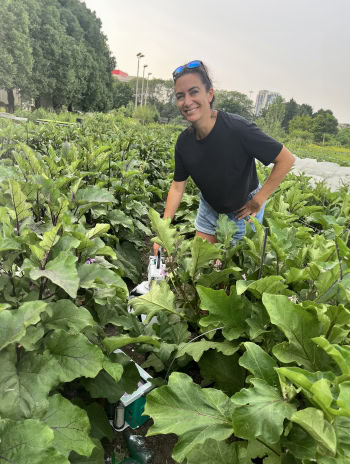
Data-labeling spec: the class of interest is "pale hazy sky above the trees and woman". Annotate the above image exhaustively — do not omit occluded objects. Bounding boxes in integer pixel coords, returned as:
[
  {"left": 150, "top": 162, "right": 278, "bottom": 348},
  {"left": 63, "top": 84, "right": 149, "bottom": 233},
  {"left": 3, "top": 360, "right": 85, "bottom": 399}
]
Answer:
[{"left": 85, "top": 0, "right": 350, "bottom": 123}]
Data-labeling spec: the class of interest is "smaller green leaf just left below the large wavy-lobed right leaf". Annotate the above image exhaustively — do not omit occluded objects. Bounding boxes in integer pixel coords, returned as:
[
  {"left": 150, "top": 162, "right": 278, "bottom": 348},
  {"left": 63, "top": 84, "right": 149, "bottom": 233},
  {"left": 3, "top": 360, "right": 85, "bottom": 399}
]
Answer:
[{"left": 239, "top": 342, "right": 279, "bottom": 387}]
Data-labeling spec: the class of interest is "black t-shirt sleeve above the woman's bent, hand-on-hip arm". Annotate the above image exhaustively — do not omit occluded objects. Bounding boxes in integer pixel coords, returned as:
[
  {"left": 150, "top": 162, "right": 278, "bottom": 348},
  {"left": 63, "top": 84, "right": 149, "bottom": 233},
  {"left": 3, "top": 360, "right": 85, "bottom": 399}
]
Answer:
[{"left": 241, "top": 122, "right": 283, "bottom": 166}]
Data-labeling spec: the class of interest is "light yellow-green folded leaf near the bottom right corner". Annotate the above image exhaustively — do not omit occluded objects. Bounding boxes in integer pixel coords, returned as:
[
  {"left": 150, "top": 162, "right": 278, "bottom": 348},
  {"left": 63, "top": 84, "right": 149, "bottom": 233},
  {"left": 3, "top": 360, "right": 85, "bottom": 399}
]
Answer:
[{"left": 291, "top": 408, "right": 337, "bottom": 455}]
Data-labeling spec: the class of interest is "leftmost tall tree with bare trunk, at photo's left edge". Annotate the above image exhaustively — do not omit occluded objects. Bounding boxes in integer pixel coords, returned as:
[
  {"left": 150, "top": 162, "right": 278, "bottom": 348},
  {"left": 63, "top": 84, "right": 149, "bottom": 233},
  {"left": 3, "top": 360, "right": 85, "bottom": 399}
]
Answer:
[{"left": 0, "top": 0, "right": 33, "bottom": 112}]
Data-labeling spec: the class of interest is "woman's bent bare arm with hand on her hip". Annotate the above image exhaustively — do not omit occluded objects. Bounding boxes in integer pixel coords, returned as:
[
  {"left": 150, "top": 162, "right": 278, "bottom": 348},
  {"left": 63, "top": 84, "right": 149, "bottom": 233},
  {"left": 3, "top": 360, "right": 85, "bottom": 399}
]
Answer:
[{"left": 237, "top": 147, "right": 295, "bottom": 219}]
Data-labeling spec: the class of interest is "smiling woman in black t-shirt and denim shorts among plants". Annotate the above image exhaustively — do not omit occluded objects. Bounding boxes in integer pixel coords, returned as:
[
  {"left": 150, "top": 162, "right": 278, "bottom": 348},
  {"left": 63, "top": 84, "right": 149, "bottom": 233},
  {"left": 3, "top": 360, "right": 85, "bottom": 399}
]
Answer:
[{"left": 153, "top": 60, "right": 295, "bottom": 255}]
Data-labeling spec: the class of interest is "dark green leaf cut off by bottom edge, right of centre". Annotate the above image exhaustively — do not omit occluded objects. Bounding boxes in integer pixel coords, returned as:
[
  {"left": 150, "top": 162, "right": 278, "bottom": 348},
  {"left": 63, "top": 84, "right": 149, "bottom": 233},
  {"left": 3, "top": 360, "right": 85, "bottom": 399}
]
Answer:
[{"left": 187, "top": 438, "right": 242, "bottom": 464}]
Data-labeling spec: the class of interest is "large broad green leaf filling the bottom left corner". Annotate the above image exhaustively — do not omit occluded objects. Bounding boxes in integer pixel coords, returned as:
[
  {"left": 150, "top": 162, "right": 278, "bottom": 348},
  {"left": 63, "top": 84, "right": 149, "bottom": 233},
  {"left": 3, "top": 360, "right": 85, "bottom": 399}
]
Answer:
[{"left": 0, "top": 419, "right": 69, "bottom": 464}]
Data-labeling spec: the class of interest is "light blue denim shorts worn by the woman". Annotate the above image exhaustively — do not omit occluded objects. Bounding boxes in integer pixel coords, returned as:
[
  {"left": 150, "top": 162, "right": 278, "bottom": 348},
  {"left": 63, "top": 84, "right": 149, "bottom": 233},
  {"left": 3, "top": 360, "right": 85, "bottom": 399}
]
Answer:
[{"left": 194, "top": 184, "right": 265, "bottom": 245}]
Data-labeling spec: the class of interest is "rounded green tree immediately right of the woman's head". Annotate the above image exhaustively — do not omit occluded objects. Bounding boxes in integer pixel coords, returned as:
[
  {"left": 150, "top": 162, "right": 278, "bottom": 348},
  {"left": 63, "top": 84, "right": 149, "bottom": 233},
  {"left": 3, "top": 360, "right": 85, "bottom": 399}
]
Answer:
[{"left": 214, "top": 90, "right": 253, "bottom": 119}]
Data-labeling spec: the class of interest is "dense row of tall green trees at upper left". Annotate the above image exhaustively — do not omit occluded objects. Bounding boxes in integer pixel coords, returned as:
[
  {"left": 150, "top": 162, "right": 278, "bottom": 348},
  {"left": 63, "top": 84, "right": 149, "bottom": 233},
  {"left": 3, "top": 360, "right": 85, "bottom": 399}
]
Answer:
[{"left": 0, "top": 0, "right": 116, "bottom": 111}]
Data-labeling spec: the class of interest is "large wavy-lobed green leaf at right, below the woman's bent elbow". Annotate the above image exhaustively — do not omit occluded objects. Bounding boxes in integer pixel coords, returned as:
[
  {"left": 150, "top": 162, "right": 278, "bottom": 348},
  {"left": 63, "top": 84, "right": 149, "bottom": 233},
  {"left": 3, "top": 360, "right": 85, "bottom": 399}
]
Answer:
[{"left": 263, "top": 294, "right": 327, "bottom": 371}]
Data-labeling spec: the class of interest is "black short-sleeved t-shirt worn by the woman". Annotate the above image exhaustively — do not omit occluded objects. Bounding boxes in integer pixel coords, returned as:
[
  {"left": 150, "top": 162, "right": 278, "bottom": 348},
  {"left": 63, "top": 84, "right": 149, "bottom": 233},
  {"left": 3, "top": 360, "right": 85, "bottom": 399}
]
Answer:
[{"left": 174, "top": 111, "right": 283, "bottom": 213}]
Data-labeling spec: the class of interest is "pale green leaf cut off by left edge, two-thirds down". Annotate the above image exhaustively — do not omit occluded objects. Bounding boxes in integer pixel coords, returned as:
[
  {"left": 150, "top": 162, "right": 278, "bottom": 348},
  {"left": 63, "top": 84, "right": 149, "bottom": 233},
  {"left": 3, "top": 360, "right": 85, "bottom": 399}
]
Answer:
[{"left": 0, "top": 301, "right": 47, "bottom": 350}]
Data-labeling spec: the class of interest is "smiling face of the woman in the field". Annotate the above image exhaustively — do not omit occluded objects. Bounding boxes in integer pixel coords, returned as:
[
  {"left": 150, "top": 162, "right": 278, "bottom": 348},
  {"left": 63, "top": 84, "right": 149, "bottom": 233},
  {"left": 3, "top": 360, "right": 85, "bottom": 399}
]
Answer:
[{"left": 175, "top": 73, "right": 214, "bottom": 123}]
